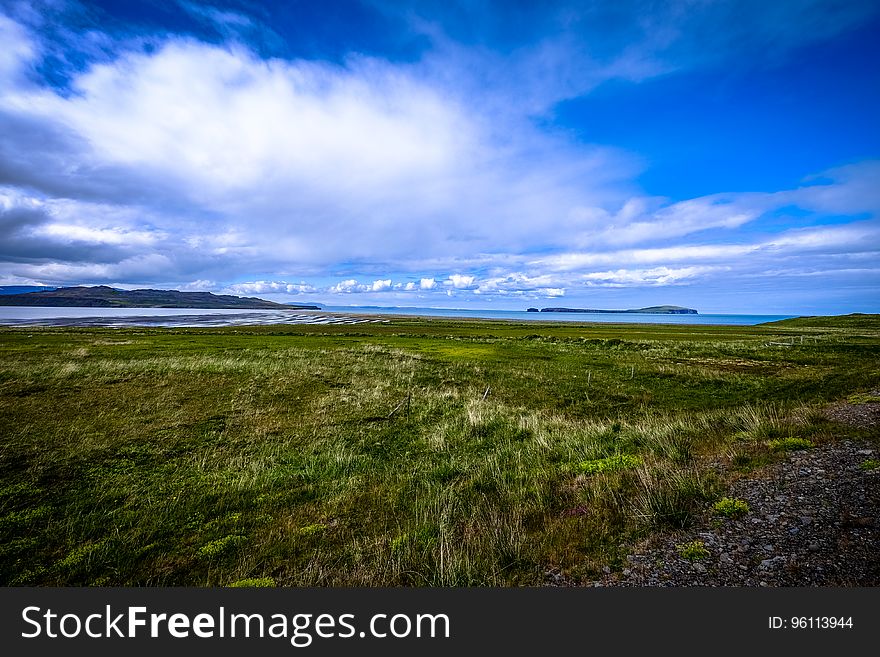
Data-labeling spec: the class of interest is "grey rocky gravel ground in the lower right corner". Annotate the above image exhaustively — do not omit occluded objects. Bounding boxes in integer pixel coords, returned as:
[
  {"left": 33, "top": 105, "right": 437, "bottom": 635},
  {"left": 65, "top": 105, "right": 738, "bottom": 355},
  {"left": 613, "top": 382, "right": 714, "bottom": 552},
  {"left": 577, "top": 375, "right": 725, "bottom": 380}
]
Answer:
[{"left": 580, "top": 393, "right": 880, "bottom": 586}]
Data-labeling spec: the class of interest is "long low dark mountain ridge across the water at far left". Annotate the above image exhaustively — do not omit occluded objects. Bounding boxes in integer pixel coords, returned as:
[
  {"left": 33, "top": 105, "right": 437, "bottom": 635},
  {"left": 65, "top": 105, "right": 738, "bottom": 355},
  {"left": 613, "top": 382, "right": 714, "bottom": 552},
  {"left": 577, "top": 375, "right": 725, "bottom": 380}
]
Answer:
[{"left": 0, "top": 285, "right": 320, "bottom": 310}]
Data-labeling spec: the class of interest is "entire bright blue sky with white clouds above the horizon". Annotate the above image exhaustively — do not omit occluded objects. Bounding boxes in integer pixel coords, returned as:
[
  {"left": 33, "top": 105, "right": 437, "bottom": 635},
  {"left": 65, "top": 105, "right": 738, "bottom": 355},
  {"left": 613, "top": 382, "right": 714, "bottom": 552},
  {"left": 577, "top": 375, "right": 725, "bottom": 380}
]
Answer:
[{"left": 0, "top": 0, "right": 880, "bottom": 314}]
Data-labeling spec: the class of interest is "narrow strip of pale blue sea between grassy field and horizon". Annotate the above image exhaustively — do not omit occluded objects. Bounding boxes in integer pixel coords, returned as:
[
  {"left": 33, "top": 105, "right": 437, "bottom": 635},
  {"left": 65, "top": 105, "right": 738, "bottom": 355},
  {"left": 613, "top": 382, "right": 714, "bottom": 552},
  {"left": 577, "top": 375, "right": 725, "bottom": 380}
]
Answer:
[{"left": 0, "top": 306, "right": 796, "bottom": 327}]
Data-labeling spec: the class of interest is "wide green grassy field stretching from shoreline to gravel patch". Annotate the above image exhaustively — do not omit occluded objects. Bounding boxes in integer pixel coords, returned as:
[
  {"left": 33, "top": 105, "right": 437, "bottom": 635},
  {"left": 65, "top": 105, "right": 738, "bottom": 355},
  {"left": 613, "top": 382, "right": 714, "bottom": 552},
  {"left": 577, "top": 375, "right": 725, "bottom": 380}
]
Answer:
[{"left": 0, "top": 315, "right": 880, "bottom": 586}]
